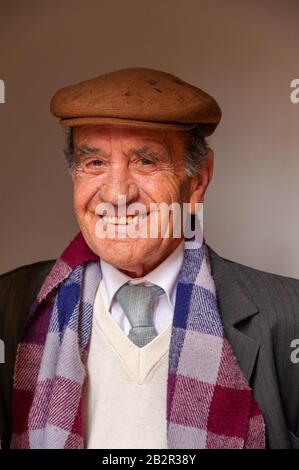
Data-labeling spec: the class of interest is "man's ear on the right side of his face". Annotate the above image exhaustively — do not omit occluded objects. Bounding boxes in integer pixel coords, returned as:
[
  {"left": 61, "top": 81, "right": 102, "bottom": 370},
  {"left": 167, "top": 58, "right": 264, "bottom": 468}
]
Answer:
[{"left": 190, "top": 149, "right": 214, "bottom": 214}]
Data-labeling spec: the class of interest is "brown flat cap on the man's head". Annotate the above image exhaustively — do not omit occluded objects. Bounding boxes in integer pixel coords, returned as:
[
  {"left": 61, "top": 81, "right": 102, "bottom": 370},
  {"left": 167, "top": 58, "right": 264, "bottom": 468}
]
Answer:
[{"left": 51, "top": 68, "right": 221, "bottom": 135}]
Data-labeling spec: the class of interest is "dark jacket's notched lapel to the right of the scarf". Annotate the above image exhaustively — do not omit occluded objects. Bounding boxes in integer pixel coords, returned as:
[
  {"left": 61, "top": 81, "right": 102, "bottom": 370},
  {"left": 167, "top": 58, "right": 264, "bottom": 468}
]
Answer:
[{"left": 208, "top": 246, "right": 260, "bottom": 383}]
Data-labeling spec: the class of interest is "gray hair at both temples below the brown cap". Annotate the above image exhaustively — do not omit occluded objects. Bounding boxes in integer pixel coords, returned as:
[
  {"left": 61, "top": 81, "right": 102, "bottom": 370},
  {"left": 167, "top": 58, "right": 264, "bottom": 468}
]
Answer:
[{"left": 64, "top": 126, "right": 209, "bottom": 177}]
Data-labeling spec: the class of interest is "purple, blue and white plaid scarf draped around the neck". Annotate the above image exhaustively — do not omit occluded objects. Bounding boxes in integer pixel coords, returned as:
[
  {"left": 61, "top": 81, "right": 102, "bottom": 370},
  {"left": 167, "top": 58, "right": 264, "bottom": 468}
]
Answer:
[{"left": 11, "top": 233, "right": 265, "bottom": 449}]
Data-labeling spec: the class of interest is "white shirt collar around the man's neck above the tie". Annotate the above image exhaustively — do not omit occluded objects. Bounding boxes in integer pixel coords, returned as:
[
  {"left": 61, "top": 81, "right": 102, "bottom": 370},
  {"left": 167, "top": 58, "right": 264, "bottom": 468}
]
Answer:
[{"left": 100, "top": 240, "right": 184, "bottom": 310}]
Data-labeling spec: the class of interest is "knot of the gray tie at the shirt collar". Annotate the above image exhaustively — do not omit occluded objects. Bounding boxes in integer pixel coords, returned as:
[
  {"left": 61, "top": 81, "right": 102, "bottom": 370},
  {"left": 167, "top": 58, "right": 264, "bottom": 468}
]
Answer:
[{"left": 115, "top": 284, "right": 165, "bottom": 328}]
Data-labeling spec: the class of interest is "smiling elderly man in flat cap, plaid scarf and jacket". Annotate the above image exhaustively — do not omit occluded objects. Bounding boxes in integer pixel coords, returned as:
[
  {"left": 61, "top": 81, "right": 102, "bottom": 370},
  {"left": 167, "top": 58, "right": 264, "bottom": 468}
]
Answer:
[{"left": 0, "top": 69, "right": 299, "bottom": 449}]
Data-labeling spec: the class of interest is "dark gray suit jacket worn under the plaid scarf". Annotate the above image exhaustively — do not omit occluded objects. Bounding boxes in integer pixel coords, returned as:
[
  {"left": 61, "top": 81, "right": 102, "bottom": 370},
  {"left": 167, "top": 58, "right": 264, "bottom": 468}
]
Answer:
[{"left": 0, "top": 247, "right": 299, "bottom": 449}]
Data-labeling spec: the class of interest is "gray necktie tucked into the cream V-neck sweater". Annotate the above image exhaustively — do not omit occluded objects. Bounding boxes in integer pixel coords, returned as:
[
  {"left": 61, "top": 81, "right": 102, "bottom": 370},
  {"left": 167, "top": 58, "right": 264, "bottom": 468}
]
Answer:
[{"left": 115, "top": 284, "right": 165, "bottom": 348}]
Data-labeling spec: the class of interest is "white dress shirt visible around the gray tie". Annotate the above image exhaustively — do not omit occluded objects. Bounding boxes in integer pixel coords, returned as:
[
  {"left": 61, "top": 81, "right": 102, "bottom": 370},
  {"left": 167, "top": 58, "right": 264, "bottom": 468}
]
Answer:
[{"left": 101, "top": 240, "right": 184, "bottom": 335}]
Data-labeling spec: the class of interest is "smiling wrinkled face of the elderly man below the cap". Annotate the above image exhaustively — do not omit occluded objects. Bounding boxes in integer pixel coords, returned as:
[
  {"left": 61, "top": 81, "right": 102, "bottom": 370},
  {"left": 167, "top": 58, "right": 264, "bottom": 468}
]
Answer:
[{"left": 73, "top": 126, "right": 212, "bottom": 277}]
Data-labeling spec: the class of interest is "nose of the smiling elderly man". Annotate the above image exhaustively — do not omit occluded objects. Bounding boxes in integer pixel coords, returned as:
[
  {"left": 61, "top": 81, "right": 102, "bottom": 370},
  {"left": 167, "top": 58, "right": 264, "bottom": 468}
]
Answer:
[{"left": 99, "top": 167, "right": 139, "bottom": 206}]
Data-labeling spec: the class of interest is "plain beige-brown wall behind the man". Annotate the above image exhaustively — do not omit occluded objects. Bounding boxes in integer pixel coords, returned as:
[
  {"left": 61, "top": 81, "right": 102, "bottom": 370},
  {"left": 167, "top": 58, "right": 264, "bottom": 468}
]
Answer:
[{"left": 0, "top": 0, "right": 299, "bottom": 278}]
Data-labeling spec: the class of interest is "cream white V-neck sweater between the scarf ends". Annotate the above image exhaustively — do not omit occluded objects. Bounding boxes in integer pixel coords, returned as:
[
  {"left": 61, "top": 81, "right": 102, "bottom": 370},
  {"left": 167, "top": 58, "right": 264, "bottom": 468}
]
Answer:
[{"left": 84, "top": 283, "right": 171, "bottom": 449}]
